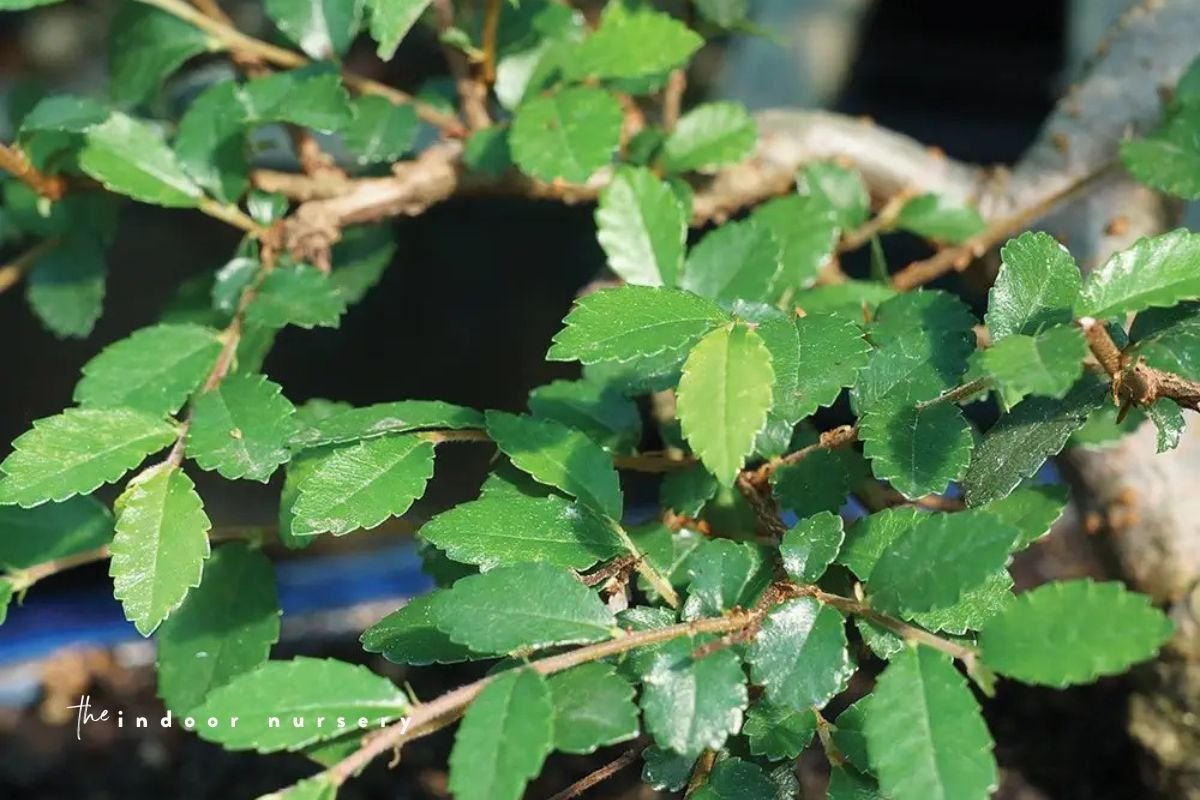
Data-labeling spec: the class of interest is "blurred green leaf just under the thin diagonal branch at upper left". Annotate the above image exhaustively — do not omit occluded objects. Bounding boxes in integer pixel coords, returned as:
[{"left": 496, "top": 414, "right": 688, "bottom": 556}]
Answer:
[{"left": 241, "top": 64, "right": 354, "bottom": 133}]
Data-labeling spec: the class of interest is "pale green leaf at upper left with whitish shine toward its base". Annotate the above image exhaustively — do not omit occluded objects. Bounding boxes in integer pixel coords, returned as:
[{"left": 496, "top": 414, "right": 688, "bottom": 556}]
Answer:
[{"left": 79, "top": 114, "right": 204, "bottom": 207}]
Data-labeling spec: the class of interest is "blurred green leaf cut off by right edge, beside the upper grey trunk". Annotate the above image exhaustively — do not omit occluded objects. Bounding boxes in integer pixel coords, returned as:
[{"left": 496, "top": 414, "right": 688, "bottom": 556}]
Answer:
[{"left": 1121, "top": 103, "right": 1200, "bottom": 200}]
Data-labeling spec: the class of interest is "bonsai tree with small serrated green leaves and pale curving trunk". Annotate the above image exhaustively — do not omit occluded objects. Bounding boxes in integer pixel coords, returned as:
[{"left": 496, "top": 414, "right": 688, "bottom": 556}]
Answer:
[{"left": 0, "top": 0, "right": 1200, "bottom": 800}]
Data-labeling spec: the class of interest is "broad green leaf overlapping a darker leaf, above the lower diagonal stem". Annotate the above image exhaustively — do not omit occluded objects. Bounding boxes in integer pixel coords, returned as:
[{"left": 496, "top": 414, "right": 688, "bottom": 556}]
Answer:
[{"left": 430, "top": 564, "right": 616, "bottom": 654}]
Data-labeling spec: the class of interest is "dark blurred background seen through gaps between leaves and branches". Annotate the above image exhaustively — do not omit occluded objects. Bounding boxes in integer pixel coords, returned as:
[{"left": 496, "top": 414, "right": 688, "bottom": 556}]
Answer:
[{"left": 0, "top": 0, "right": 1142, "bottom": 800}]
